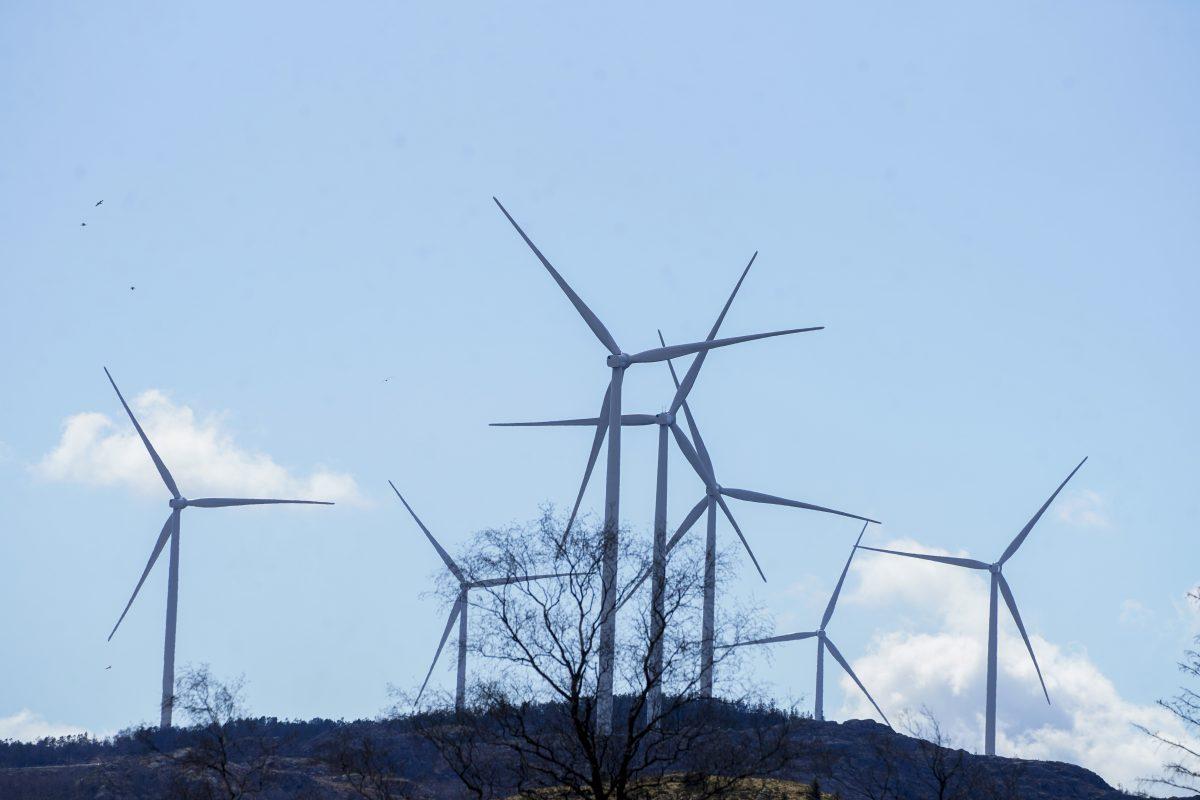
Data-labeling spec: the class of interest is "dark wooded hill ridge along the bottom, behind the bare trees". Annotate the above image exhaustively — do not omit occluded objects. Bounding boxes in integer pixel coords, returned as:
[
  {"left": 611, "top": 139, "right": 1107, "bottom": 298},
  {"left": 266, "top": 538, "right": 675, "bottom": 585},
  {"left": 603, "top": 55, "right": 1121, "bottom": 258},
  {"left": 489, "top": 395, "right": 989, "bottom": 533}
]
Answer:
[{"left": 0, "top": 718, "right": 1180, "bottom": 800}]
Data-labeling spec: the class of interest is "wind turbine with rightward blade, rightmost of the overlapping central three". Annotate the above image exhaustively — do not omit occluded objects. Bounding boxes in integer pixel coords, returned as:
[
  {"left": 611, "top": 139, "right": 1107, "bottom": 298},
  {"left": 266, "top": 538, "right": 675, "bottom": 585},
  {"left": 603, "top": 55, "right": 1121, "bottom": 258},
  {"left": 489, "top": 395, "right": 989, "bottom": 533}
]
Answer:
[{"left": 659, "top": 340, "right": 877, "bottom": 697}]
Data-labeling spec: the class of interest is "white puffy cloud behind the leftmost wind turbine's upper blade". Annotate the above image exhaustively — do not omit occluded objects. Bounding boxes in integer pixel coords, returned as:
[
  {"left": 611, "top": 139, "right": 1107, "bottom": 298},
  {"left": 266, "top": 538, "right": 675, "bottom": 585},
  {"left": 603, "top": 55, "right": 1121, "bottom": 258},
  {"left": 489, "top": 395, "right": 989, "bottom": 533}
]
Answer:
[{"left": 32, "top": 390, "right": 361, "bottom": 503}]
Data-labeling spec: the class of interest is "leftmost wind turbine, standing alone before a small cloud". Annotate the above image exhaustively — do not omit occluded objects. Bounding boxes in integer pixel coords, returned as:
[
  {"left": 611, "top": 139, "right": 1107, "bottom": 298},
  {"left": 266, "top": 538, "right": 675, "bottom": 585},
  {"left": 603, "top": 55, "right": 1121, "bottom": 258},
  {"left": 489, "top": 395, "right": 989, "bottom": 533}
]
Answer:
[{"left": 104, "top": 367, "right": 334, "bottom": 729}]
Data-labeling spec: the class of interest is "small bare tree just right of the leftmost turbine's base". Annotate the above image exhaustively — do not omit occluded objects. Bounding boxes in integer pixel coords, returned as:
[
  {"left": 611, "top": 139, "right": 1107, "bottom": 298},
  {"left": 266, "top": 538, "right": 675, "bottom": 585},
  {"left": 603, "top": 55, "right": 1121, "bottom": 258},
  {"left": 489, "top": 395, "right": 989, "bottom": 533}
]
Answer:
[{"left": 139, "top": 664, "right": 276, "bottom": 800}]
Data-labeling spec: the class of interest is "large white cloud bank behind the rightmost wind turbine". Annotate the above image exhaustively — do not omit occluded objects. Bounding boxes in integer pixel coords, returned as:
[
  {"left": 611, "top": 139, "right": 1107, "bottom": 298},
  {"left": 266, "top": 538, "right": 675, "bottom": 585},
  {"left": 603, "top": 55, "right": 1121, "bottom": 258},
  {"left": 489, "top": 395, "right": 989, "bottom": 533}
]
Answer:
[{"left": 841, "top": 540, "right": 1187, "bottom": 788}]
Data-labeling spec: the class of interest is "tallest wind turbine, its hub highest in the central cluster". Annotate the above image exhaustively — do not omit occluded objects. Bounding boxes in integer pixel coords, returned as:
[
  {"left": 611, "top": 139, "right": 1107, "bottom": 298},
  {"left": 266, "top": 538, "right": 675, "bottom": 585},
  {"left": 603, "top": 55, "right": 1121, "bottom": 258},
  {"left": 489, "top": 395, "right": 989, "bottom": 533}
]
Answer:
[{"left": 492, "top": 197, "right": 818, "bottom": 735}]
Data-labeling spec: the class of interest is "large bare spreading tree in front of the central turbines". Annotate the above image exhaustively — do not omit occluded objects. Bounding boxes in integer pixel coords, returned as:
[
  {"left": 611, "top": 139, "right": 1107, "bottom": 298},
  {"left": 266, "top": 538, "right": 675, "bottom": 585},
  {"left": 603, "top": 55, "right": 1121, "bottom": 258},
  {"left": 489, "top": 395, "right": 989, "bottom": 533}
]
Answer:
[{"left": 414, "top": 512, "right": 799, "bottom": 800}]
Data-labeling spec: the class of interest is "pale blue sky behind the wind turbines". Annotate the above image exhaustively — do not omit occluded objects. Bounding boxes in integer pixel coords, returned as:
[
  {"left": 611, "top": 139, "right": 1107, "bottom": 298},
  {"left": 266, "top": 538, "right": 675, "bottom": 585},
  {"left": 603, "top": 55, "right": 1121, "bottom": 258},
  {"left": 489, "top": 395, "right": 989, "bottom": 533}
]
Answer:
[{"left": 0, "top": 2, "right": 1200, "bottom": 778}]
